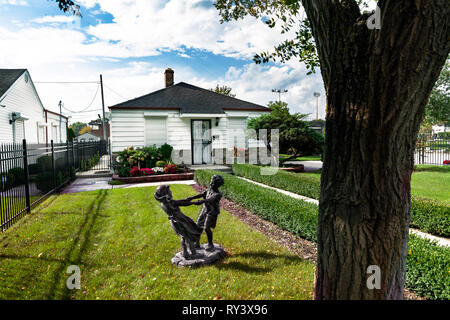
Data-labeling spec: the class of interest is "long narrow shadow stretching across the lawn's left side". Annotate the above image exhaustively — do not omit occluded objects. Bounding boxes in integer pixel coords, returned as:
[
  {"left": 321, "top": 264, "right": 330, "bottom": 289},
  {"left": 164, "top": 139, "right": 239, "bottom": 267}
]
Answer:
[{"left": 46, "top": 190, "right": 108, "bottom": 299}]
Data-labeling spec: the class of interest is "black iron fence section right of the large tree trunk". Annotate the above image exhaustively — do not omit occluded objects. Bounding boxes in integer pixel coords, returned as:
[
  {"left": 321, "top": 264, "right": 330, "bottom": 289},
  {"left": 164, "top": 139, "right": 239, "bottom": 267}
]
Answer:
[{"left": 414, "top": 134, "right": 450, "bottom": 165}]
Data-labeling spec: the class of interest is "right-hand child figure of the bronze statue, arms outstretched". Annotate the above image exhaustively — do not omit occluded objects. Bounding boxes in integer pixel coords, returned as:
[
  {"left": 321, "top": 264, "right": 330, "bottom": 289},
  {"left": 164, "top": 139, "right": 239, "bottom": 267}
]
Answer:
[{"left": 184, "top": 175, "right": 224, "bottom": 251}]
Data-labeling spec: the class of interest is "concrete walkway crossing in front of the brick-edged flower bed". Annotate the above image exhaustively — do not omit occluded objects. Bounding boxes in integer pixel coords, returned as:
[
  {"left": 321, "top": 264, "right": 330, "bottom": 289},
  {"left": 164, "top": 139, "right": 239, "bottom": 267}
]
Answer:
[{"left": 60, "top": 177, "right": 195, "bottom": 194}]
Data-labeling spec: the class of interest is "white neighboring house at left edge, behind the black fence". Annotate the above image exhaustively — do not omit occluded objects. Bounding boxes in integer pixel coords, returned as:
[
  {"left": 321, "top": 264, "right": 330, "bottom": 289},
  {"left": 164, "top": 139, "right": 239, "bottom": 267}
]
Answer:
[{"left": 0, "top": 69, "right": 67, "bottom": 144}]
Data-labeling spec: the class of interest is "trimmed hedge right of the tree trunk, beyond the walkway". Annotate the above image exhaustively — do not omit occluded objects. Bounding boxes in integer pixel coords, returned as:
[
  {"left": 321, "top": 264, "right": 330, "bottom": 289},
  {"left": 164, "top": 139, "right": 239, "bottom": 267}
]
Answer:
[{"left": 411, "top": 196, "right": 450, "bottom": 237}]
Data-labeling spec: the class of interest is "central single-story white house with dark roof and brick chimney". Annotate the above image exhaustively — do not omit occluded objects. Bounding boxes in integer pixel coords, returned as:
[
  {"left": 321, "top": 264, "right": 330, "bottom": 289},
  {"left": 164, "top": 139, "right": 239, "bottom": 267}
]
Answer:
[{"left": 109, "top": 68, "right": 270, "bottom": 164}]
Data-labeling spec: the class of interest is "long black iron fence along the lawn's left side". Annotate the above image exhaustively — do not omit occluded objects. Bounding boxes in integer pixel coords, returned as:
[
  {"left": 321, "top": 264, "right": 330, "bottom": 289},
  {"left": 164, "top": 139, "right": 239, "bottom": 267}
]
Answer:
[{"left": 0, "top": 140, "right": 109, "bottom": 231}]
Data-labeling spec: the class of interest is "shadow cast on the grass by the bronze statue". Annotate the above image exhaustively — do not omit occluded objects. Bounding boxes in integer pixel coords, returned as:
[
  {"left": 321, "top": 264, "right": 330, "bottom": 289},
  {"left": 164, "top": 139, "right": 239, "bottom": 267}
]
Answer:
[{"left": 216, "top": 252, "right": 304, "bottom": 274}]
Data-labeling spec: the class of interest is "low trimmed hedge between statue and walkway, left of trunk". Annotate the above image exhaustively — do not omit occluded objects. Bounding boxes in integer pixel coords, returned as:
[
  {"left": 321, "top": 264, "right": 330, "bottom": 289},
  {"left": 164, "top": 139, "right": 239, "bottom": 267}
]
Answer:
[{"left": 194, "top": 170, "right": 317, "bottom": 241}]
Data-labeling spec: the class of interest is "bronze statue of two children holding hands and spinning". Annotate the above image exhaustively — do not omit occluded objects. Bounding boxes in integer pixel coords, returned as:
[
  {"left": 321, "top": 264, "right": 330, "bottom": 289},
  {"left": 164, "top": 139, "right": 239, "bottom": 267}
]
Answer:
[{"left": 154, "top": 175, "right": 224, "bottom": 259}]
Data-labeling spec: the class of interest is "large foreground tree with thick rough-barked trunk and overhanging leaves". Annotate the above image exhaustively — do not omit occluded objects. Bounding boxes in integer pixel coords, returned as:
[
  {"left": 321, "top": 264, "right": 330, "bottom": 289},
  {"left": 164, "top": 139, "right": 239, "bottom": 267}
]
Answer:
[{"left": 215, "top": 0, "right": 450, "bottom": 299}]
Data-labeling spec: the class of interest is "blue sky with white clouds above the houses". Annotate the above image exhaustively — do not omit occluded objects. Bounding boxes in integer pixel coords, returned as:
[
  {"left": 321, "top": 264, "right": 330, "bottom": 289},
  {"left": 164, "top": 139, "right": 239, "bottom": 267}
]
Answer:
[{"left": 0, "top": 0, "right": 342, "bottom": 123}]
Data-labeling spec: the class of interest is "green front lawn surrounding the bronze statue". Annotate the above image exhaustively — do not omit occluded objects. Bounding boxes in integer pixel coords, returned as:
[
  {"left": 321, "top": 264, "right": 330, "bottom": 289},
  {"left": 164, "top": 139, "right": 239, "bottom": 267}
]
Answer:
[{"left": 0, "top": 185, "right": 314, "bottom": 299}]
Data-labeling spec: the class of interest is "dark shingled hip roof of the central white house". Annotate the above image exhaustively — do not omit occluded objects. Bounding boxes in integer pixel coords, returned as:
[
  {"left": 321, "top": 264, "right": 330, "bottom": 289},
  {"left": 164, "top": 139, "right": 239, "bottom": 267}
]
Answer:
[{"left": 109, "top": 82, "right": 270, "bottom": 114}]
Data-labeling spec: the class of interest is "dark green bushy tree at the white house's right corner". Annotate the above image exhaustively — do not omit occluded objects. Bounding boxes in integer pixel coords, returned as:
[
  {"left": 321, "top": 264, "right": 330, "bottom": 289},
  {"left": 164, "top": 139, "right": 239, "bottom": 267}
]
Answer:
[{"left": 247, "top": 101, "right": 323, "bottom": 162}]
